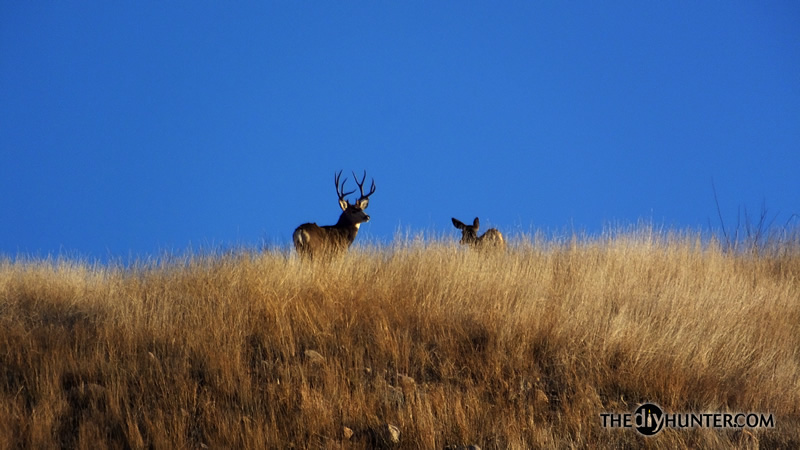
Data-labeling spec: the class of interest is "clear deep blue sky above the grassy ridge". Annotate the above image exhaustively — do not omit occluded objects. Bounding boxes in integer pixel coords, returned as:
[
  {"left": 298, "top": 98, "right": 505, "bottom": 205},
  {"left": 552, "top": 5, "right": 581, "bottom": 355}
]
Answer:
[{"left": 0, "top": 1, "right": 800, "bottom": 260}]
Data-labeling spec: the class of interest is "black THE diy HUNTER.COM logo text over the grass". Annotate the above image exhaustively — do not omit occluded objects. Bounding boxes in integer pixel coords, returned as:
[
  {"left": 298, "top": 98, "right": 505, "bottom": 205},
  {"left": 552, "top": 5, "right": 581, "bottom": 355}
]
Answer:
[{"left": 600, "top": 403, "right": 775, "bottom": 436}]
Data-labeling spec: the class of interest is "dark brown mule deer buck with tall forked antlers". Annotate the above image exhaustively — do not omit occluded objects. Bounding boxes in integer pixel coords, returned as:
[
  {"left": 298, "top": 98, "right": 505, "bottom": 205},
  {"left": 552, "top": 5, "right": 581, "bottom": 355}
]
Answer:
[{"left": 292, "top": 170, "right": 375, "bottom": 257}]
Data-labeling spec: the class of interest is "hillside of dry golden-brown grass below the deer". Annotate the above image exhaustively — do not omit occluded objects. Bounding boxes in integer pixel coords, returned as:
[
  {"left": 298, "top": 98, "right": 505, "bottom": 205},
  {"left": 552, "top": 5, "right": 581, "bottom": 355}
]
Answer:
[{"left": 0, "top": 231, "right": 800, "bottom": 449}]
